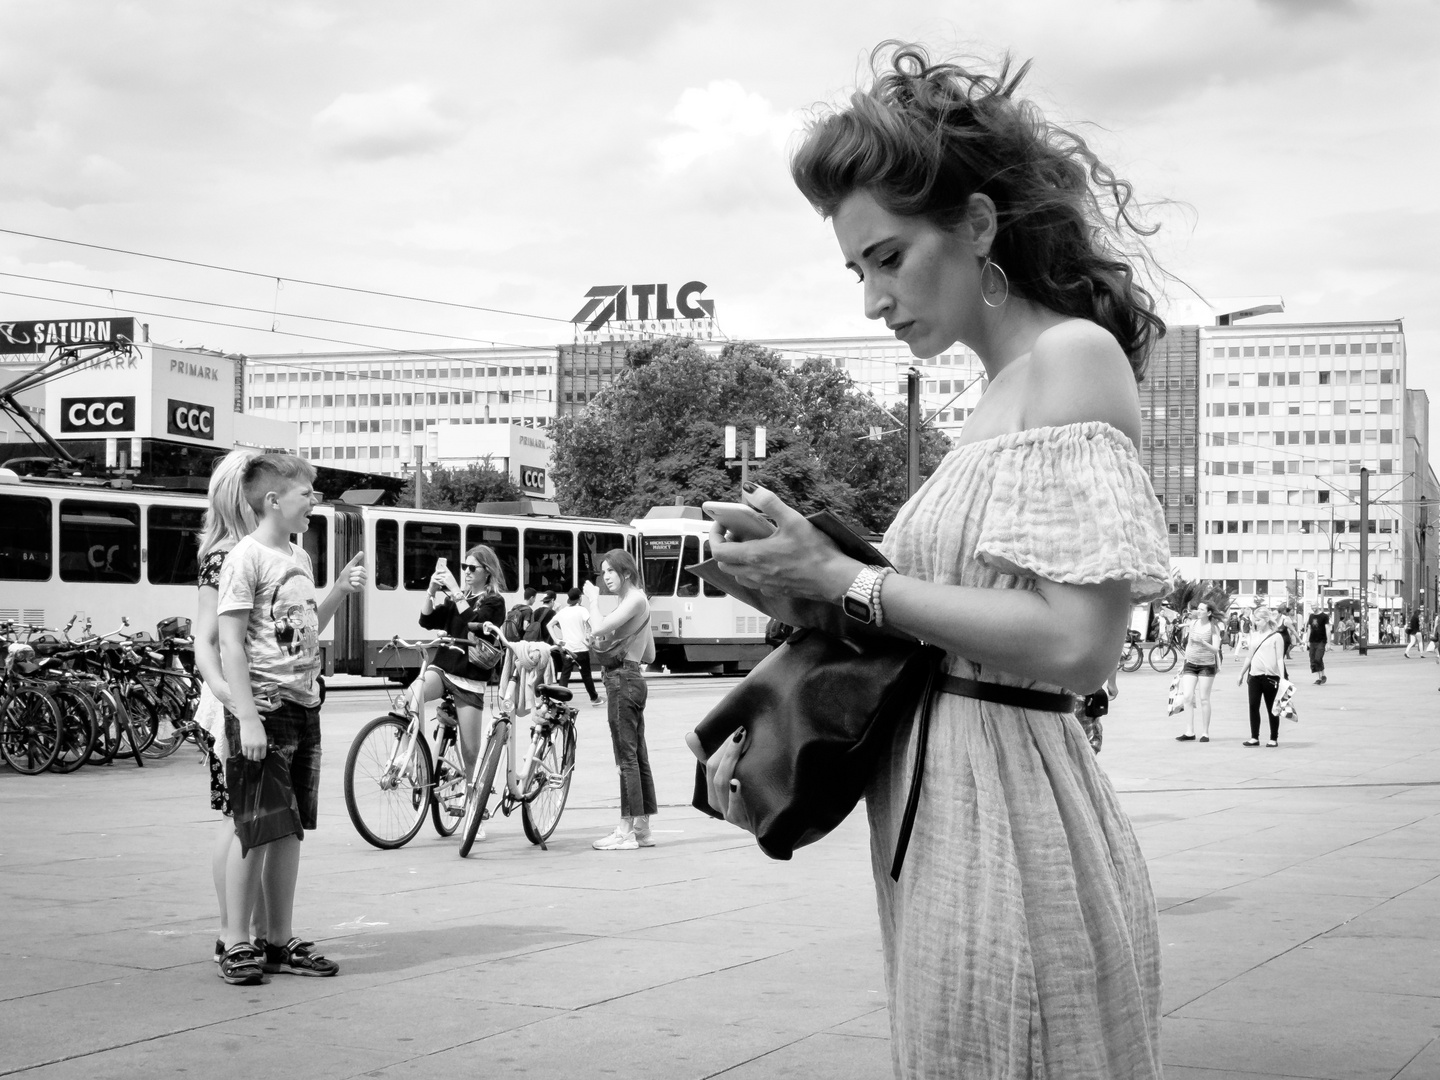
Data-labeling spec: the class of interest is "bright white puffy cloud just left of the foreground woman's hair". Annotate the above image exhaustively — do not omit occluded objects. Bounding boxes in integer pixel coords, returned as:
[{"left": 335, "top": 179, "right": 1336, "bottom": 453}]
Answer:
[{"left": 655, "top": 79, "right": 799, "bottom": 176}]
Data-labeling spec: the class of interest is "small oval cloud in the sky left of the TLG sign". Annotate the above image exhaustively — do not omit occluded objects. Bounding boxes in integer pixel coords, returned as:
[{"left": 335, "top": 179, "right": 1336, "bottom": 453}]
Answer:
[{"left": 311, "top": 82, "right": 461, "bottom": 161}]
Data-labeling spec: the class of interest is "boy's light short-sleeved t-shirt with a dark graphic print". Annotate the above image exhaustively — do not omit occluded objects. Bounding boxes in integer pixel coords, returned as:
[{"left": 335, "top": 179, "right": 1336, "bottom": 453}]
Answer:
[{"left": 216, "top": 536, "right": 320, "bottom": 713}]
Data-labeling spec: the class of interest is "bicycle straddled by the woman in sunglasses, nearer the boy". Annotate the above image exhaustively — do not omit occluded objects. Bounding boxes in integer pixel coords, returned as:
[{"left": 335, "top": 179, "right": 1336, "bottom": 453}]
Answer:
[{"left": 346, "top": 636, "right": 467, "bottom": 850}]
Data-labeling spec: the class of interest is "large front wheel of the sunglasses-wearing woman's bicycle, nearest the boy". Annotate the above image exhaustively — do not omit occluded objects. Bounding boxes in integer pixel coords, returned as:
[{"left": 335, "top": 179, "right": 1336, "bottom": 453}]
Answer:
[{"left": 346, "top": 716, "right": 432, "bottom": 850}]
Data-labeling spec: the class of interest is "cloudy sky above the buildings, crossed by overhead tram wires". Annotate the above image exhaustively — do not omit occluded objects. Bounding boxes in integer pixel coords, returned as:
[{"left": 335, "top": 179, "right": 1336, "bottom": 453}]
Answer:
[{"left": 0, "top": 0, "right": 1440, "bottom": 426}]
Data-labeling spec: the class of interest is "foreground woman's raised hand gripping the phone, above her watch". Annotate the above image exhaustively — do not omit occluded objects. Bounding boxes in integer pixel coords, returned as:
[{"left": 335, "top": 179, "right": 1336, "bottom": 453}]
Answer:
[{"left": 710, "top": 485, "right": 861, "bottom": 603}]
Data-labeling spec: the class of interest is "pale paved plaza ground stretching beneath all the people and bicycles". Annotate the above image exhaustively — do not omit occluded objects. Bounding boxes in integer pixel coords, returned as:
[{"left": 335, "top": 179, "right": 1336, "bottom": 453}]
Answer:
[{"left": 0, "top": 649, "right": 1440, "bottom": 1080}]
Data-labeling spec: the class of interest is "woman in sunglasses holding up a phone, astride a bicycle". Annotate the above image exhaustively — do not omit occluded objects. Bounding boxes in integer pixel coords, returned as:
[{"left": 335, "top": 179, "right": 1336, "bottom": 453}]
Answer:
[{"left": 412, "top": 544, "right": 505, "bottom": 775}]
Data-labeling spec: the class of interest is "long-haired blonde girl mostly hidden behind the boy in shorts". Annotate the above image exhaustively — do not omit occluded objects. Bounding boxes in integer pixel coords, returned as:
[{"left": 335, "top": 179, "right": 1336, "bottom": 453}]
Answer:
[{"left": 193, "top": 449, "right": 268, "bottom": 963}]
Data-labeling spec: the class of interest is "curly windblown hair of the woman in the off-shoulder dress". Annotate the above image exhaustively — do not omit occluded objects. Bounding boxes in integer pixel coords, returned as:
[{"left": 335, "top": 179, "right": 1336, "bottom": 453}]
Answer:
[{"left": 791, "top": 42, "right": 1165, "bottom": 380}]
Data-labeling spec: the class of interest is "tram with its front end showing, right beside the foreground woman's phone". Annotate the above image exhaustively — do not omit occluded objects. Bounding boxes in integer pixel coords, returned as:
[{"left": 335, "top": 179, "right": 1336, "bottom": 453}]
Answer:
[{"left": 631, "top": 507, "right": 769, "bottom": 674}]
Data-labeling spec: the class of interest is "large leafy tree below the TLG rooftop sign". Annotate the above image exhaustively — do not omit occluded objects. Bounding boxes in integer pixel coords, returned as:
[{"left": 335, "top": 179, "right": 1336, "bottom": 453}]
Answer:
[{"left": 552, "top": 338, "right": 949, "bottom": 531}]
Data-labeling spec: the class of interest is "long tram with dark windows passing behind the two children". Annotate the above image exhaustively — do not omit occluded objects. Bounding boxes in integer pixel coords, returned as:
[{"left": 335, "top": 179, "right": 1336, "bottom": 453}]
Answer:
[{"left": 0, "top": 468, "right": 639, "bottom": 678}]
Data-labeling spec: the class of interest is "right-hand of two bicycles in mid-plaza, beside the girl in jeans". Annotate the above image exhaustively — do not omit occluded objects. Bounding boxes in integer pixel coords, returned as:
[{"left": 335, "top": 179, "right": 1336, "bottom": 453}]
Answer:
[{"left": 459, "top": 634, "right": 579, "bottom": 858}]
